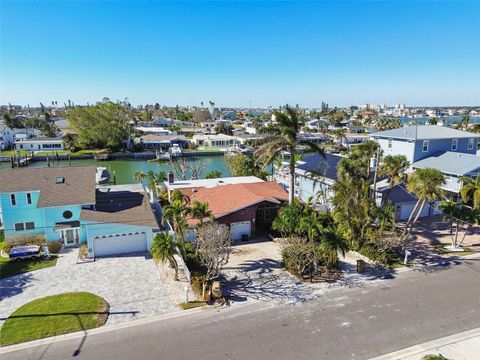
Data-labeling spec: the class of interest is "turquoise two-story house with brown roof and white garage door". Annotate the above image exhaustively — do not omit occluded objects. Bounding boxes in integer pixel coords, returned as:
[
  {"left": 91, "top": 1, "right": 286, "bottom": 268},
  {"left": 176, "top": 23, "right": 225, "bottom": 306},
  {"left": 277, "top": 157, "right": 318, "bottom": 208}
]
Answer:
[{"left": 0, "top": 166, "right": 160, "bottom": 257}]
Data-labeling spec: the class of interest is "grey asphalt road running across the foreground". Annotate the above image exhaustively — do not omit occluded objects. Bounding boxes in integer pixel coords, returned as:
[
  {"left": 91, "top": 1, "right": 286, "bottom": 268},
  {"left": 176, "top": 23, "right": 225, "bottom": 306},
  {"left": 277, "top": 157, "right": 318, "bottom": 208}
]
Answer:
[{"left": 1, "top": 259, "right": 480, "bottom": 360}]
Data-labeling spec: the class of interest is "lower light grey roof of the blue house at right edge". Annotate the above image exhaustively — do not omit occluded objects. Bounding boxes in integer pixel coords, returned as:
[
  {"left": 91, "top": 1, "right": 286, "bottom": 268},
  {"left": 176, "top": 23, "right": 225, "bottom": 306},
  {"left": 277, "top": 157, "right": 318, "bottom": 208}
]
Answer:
[{"left": 412, "top": 151, "right": 480, "bottom": 176}]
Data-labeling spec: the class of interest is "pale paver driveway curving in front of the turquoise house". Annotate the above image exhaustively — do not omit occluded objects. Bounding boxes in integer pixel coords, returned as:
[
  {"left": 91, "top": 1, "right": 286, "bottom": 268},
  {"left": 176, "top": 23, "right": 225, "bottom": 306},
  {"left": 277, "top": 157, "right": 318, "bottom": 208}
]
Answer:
[{"left": 0, "top": 249, "right": 179, "bottom": 324}]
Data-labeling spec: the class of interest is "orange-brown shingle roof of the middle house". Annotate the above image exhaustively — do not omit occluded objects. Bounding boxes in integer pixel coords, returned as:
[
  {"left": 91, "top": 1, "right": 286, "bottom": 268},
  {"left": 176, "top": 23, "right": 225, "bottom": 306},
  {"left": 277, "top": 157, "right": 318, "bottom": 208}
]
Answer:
[{"left": 186, "top": 182, "right": 288, "bottom": 222}]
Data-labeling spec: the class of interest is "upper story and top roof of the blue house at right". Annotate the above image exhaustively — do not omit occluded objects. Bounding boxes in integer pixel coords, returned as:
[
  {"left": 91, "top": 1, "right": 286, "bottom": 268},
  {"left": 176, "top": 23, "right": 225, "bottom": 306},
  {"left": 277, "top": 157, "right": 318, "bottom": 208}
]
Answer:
[{"left": 373, "top": 125, "right": 480, "bottom": 164}]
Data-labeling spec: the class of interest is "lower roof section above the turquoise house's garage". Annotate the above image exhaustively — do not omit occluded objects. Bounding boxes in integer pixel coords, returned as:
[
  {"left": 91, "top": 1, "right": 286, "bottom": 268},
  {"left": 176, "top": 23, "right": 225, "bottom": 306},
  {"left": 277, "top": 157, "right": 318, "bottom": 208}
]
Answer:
[{"left": 80, "top": 190, "right": 159, "bottom": 228}]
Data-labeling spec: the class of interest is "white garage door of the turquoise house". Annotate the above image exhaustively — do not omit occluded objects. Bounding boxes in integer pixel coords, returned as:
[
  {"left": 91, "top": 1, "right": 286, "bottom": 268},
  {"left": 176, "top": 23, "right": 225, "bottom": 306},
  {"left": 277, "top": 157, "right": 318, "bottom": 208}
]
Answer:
[{"left": 93, "top": 231, "right": 148, "bottom": 256}]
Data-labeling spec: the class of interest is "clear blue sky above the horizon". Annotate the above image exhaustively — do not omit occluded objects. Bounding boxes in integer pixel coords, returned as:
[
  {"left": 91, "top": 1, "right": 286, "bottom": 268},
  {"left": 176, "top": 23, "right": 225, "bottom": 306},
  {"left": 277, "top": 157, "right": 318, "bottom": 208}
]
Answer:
[{"left": 0, "top": 1, "right": 480, "bottom": 107}]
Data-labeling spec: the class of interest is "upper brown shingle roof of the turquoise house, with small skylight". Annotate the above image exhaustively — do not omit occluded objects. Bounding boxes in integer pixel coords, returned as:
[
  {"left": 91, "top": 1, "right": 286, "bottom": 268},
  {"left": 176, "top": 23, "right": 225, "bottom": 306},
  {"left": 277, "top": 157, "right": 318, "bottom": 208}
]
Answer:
[{"left": 0, "top": 166, "right": 96, "bottom": 208}]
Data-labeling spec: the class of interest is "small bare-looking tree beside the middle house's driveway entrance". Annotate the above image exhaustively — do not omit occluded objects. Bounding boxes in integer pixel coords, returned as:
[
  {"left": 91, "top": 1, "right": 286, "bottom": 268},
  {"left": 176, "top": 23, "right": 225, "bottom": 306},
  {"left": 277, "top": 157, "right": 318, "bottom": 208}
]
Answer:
[{"left": 197, "top": 222, "right": 232, "bottom": 291}]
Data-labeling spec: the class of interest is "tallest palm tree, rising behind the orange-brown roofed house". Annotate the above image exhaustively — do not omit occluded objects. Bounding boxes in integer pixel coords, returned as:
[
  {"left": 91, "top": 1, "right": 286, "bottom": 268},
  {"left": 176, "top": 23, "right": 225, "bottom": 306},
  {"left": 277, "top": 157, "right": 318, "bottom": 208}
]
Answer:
[{"left": 255, "top": 105, "right": 324, "bottom": 204}]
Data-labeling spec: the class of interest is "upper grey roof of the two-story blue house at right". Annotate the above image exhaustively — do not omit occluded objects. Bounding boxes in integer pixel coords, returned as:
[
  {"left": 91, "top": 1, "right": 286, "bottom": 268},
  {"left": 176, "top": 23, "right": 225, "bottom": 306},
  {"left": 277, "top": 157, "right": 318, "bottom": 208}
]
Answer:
[{"left": 372, "top": 125, "right": 480, "bottom": 140}]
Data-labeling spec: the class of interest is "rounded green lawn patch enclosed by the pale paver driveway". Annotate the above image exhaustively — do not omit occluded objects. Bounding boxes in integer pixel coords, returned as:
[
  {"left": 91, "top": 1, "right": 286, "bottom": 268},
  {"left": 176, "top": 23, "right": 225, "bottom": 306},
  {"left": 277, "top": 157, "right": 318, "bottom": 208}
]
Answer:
[{"left": 0, "top": 292, "right": 109, "bottom": 346}]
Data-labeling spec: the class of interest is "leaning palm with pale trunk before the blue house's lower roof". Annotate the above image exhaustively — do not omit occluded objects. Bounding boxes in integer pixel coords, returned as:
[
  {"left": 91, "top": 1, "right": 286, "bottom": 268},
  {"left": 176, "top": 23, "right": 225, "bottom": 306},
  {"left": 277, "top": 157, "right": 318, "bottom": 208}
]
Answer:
[{"left": 404, "top": 168, "right": 445, "bottom": 236}]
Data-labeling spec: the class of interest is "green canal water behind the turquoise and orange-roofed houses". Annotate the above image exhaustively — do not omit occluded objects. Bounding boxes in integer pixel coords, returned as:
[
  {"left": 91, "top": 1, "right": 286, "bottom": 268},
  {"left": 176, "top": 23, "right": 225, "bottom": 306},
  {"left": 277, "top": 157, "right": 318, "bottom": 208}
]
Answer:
[{"left": 0, "top": 156, "right": 230, "bottom": 184}]
